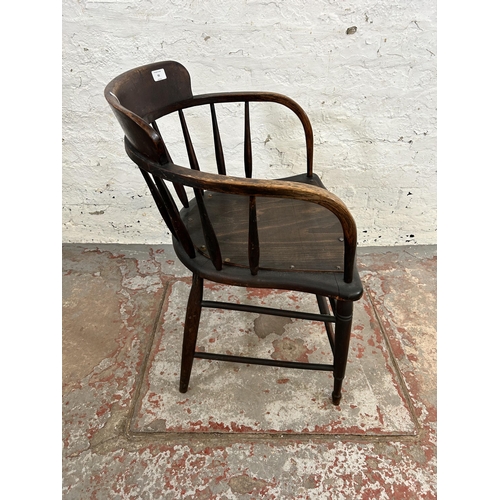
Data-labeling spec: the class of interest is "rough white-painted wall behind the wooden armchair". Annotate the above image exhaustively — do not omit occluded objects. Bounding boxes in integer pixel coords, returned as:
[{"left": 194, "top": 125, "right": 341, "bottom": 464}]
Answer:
[{"left": 62, "top": 0, "right": 436, "bottom": 245}]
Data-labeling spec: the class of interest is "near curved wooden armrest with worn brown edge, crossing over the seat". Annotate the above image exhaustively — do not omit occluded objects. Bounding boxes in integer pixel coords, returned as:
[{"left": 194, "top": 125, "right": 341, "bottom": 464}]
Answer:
[{"left": 125, "top": 138, "right": 357, "bottom": 283}]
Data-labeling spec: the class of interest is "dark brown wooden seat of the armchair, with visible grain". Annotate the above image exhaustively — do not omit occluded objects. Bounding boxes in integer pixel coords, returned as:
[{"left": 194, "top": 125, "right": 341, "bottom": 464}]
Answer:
[{"left": 174, "top": 174, "right": 362, "bottom": 300}]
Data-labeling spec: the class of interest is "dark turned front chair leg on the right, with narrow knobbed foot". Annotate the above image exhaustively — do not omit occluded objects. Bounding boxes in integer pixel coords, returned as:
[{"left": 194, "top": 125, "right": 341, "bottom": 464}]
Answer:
[{"left": 332, "top": 300, "right": 353, "bottom": 406}]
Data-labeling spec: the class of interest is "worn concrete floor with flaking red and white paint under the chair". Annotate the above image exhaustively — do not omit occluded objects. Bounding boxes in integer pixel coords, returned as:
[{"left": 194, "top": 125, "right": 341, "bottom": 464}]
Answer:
[{"left": 63, "top": 244, "right": 437, "bottom": 500}]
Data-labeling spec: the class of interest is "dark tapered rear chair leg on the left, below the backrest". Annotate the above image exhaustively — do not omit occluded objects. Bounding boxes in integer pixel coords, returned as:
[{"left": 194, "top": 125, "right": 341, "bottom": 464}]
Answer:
[{"left": 179, "top": 274, "right": 203, "bottom": 393}]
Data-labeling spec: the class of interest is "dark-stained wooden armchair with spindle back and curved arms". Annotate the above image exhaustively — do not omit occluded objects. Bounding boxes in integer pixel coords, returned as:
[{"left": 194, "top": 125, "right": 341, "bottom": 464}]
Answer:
[{"left": 105, "top": 61, "right": 363, "bottom": 405}]
